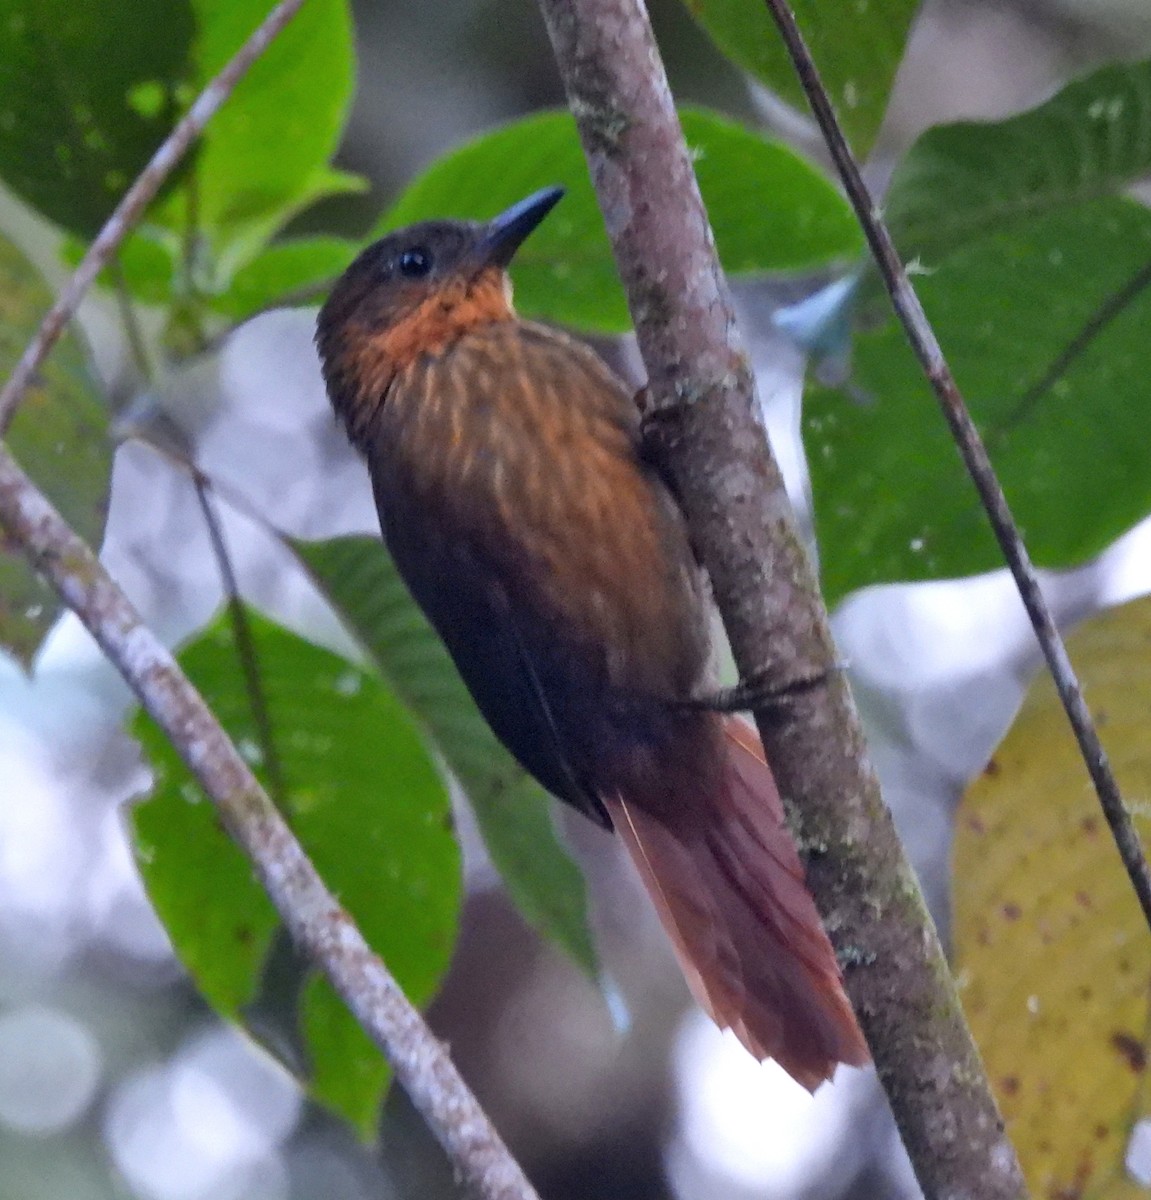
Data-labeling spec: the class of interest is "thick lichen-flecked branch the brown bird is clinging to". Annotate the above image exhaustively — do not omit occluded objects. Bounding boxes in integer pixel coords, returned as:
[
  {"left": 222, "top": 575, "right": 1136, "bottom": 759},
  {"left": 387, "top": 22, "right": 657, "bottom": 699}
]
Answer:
[{"left": 540, "top": 0, "right": 1025, "bottom": 1200}]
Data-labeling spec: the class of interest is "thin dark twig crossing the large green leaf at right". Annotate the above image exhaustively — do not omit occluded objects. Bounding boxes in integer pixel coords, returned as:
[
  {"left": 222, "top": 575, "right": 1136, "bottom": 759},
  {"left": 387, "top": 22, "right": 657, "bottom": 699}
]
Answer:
[{"left": 765, "top": 0, "right": 1151, "bottom": 926}]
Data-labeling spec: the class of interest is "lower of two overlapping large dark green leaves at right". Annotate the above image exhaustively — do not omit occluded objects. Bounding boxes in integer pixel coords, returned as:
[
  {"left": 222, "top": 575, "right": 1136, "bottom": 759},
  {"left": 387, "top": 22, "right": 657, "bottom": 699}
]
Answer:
[{"left": 804, "top": 200, "right": 1151, "bottom": 602}]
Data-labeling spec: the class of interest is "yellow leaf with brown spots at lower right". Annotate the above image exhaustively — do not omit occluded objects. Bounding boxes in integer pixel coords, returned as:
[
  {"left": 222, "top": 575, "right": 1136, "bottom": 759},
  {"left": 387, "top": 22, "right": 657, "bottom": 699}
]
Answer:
[{"left": 953, "top": 600, "right": 1151, "bottom": 1200}]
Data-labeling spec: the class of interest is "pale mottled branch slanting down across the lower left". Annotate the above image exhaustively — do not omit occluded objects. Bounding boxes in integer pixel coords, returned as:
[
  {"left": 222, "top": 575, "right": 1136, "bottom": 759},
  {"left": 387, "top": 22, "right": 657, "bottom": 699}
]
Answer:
[{"left": 0, "top": 445, "right": 538, "bottom": 1200}]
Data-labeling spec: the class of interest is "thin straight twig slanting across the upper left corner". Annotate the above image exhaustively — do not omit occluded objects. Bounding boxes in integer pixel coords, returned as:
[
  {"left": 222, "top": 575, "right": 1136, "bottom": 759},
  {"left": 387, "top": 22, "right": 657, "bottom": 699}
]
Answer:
[{"left": 0, "top": 0, "right": 304, "bottom": 437}]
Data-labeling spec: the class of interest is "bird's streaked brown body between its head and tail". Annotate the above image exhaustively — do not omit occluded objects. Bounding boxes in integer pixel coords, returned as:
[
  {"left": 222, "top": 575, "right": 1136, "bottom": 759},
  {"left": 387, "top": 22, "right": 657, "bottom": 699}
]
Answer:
[{"left": 370, "top": 323, "right": 707, "bottom": 822}]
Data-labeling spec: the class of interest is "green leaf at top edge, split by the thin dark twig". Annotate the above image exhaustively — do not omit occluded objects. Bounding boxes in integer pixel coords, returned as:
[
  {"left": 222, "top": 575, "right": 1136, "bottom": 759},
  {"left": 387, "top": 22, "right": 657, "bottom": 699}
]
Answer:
[{"left": 685, "top": 0, "right": 919, "bottom": 157}]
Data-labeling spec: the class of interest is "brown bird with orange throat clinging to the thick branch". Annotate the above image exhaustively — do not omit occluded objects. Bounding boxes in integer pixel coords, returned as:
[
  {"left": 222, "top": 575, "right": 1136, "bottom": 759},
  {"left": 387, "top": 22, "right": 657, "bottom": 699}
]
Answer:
[{"left": 316, "top": 188, "right": 868, "bottom": 1088}]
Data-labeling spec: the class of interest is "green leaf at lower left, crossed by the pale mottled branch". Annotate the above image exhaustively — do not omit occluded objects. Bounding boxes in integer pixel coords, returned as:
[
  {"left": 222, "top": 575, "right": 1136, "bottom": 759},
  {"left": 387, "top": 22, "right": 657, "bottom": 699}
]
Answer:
[{"left": 133, "top": 613, "right": 461, "bottom": 1134}]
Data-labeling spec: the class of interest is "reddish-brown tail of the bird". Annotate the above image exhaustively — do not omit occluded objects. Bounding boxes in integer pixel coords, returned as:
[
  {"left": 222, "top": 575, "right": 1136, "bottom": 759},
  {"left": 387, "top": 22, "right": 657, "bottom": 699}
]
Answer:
[{"left": 604, "top": 718, "right": 869, "bottom": 1091}]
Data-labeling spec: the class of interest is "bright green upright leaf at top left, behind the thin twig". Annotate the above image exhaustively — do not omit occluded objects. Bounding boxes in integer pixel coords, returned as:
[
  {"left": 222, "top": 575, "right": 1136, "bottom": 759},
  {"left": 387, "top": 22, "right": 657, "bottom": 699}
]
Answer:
[{"left": 180, "top": 0, "right": 361, "bottom": 279}]
